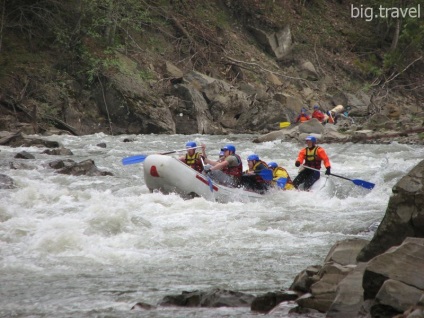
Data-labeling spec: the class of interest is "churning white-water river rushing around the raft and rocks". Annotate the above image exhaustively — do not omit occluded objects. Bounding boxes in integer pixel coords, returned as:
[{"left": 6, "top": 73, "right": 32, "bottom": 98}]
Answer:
[{"left": 0, "top": 134, "right": 424, "bottom": 317}]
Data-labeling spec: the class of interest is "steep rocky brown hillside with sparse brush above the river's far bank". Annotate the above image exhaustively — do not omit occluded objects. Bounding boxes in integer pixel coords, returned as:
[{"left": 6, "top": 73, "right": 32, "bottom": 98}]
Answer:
[{"left": 0, "top": 0, "right": 424, "bottom": 134}]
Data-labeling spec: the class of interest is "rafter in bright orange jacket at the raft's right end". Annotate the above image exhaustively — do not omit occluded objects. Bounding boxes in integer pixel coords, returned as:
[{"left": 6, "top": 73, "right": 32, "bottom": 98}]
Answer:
[{"left": 293, "top": 136, "right": 331, "bottom": 190}]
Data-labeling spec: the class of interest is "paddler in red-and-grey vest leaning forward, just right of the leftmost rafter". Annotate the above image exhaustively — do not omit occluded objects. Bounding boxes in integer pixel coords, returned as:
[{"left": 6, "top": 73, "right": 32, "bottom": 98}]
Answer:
[{"left": 202, "top": 144, "right": 243, "bottom": 187}]
